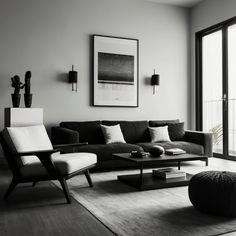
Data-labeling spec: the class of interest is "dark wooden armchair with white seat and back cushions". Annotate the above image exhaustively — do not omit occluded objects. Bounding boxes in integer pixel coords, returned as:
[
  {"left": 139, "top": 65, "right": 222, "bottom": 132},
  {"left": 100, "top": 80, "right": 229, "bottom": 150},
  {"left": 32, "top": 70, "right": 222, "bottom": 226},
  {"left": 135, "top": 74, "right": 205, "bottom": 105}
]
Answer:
[{"left": 0, "top": 125, "right": 97, "bottom": 203}]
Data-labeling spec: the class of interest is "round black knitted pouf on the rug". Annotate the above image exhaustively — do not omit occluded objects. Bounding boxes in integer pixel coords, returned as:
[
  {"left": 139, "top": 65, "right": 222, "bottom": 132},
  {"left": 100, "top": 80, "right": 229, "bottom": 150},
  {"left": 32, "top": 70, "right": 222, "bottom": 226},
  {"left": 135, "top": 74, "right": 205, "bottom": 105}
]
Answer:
[{"left": 188, "top": 171, "right": 236, "bottom": 217}]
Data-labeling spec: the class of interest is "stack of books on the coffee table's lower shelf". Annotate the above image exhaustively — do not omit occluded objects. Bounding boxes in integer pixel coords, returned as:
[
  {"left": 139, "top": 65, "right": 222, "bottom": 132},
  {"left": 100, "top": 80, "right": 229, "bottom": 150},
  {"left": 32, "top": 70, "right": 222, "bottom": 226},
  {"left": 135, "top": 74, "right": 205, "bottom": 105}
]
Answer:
[{"left": 152, "top": 167, "right": 186, "bottom": 179}]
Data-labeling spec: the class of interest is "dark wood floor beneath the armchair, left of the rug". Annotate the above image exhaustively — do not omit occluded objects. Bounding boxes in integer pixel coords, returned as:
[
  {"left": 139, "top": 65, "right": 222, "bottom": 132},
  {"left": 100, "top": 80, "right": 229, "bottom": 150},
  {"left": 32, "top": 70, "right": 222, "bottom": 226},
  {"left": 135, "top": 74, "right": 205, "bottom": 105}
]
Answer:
[{"left": 0, "top": 166, "right": 114, "bottom": 236}]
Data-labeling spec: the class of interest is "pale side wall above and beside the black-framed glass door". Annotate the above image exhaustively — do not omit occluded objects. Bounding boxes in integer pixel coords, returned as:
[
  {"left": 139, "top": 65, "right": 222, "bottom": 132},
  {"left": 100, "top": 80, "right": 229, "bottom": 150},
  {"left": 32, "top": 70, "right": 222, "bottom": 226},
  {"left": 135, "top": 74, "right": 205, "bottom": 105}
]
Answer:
[{"left": 190, "top": 0, "right": 236, "bottom": 128}]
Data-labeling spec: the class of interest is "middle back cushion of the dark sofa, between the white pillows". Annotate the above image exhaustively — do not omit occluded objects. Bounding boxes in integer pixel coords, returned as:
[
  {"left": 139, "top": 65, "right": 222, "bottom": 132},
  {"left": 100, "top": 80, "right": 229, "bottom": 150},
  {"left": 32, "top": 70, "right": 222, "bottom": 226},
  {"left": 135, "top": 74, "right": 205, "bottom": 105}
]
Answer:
[{"left": 102, "top": 120, "right": 150, "bottom": 143}]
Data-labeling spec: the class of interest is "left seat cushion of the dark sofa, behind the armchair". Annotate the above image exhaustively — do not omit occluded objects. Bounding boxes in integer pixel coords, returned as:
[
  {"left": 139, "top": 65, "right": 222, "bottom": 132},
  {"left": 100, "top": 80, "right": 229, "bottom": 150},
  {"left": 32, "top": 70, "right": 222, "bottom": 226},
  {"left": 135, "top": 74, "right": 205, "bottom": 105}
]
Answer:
[{"left": 74, "top": 143, "right": 143, "bottom": 161}]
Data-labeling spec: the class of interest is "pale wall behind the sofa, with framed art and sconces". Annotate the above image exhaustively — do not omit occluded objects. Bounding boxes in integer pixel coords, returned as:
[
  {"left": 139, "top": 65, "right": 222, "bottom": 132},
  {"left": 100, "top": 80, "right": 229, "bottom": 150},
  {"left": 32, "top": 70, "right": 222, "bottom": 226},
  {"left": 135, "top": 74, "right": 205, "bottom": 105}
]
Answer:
[{"left": 0, "top": 0, "right": 190, "bottom": 132}]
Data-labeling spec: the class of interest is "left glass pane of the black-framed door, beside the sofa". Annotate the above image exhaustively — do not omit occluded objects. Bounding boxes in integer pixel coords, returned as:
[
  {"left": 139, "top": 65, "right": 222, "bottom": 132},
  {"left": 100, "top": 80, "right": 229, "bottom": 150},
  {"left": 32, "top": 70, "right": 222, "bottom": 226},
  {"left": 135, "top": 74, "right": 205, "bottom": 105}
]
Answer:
[{"left": 202, "top": 30, "right": 223, "bottom": 154}]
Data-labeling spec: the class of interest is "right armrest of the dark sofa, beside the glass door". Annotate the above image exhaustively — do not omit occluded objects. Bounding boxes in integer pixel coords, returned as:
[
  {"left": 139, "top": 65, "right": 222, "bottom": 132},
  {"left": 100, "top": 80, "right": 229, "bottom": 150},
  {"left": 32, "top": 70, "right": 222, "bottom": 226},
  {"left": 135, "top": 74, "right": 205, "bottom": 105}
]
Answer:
[{"left": 184, "top": 130, "right": 213, "bottom": 157}]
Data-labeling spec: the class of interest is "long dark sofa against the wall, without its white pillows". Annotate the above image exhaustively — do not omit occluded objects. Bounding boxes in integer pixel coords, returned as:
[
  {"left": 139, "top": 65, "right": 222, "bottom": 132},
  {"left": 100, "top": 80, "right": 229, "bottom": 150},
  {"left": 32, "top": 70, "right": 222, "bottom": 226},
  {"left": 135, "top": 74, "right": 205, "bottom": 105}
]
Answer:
[{"left": 51, "top": 120, "right": 212, "bottom": 169}]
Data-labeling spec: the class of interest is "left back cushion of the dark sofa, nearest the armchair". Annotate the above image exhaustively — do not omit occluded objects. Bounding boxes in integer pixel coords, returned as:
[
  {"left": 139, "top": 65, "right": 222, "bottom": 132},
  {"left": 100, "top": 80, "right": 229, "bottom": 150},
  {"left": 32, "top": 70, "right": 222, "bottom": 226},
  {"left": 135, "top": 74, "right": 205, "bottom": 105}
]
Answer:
[{"left": 60, "top": 121, "right": 105, "bottom": 144}]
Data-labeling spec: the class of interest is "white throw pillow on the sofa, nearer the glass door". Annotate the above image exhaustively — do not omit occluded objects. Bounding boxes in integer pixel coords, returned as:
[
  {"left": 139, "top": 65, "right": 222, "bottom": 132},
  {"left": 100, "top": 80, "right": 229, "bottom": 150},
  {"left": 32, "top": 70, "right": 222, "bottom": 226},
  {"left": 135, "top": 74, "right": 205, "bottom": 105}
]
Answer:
[{"left": 148, "top": 126, "right": 170, "bottom": 143}]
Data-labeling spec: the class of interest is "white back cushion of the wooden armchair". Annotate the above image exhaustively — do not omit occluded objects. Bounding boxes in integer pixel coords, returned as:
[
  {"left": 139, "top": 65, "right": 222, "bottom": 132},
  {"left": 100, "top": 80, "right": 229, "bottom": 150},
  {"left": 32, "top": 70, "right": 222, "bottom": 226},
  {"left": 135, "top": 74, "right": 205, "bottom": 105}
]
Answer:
[{"left": 7, "top": 125, "right": 53, "bottom": 165}]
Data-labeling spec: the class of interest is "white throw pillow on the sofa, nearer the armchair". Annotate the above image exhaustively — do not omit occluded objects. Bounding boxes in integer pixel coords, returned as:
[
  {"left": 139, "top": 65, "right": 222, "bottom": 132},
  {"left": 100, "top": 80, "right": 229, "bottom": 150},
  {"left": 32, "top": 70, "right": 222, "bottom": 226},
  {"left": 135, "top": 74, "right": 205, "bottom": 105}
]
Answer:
[{"left": 101, "top": 124, "right": 126, "bottom": 144}]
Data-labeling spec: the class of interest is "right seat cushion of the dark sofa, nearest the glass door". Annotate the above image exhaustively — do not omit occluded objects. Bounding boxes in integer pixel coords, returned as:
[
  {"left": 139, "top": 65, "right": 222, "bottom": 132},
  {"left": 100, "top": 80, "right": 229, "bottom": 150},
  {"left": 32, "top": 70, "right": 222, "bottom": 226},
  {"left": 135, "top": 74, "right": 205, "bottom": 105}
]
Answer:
[{"left": 137, "top": 141, "right": 204, "bottom": 154}]
